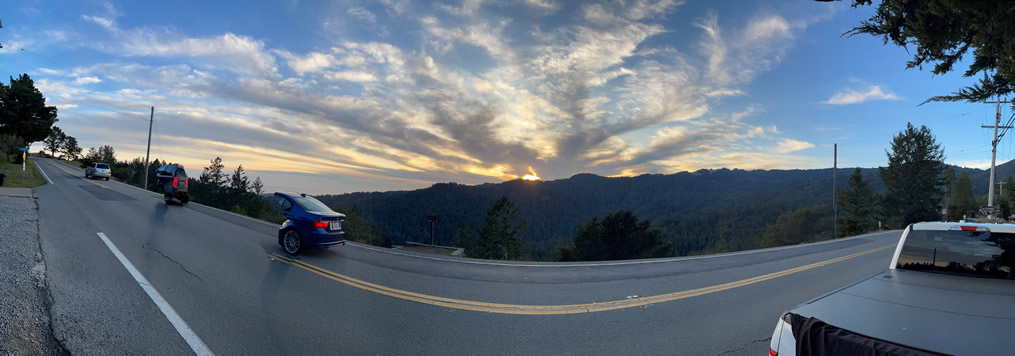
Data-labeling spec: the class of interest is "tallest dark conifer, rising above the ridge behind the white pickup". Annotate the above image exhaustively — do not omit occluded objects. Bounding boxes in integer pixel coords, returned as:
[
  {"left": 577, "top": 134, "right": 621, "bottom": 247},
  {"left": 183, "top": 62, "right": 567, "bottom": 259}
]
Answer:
[{"left": 878, "top": 123, "right": 944, "bottom": 228}]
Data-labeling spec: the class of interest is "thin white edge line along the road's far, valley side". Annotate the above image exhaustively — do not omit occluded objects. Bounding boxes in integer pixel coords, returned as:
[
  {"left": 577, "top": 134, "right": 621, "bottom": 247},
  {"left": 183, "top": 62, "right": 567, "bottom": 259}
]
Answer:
[{"left": 346, "top": 230, "right": 895, "bottom": 268}]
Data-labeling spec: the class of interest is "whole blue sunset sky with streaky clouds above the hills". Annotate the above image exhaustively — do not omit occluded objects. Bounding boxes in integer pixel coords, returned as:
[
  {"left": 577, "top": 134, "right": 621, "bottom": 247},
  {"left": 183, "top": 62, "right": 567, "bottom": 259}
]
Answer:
[{"left": 0, "top": 0, "right": 1013, "bottom": 194}]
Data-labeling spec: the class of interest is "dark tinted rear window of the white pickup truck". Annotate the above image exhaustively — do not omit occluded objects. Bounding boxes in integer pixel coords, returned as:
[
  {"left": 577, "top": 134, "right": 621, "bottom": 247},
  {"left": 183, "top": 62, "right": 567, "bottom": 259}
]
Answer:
[{"left": 895, "top": 230, "right": 1015, "bottom": 280}]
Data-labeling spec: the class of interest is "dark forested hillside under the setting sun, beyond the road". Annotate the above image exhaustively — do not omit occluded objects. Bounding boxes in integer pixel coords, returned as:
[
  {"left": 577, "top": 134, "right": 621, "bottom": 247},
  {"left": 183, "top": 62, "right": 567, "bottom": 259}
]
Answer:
[{"left": 317, "top": 163, "right": 1011, "bottom": 257}]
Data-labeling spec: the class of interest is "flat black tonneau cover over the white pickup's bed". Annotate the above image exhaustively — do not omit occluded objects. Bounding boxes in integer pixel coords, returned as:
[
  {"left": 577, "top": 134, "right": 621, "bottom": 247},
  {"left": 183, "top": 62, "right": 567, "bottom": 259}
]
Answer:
[{"left": 787, "top": 270, "right": 1015, "bottom": 355}]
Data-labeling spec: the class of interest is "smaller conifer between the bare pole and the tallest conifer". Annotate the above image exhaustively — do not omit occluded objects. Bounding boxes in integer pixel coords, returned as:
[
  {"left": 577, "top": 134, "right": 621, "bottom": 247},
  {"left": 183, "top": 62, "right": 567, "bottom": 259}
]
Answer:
[{"left": 836, "top": 167, "right": 879, "bottom": 237}]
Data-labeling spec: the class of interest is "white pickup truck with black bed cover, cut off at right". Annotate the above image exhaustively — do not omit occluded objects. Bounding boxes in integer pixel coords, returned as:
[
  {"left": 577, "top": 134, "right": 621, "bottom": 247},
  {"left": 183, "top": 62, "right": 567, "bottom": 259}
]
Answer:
[{"left": 768, "top": 222, "right": 1015, "bottom": 356}]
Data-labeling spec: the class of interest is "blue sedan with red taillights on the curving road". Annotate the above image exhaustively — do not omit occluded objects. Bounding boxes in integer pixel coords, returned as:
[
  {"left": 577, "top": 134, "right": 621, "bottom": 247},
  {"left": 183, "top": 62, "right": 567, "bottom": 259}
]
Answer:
[{"left": 275, "top": 192, "right": 345, "bottom": 255}]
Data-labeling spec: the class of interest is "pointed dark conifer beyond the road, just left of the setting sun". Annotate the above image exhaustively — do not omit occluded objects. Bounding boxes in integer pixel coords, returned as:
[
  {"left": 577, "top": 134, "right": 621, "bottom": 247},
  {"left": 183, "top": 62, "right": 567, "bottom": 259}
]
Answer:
[{"left": 475, "top": 197, "right": 525, "bottom": 260}]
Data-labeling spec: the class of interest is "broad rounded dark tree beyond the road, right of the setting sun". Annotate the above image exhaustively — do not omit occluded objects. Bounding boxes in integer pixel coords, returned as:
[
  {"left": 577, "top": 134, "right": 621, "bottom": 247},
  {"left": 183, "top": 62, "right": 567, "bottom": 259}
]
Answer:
[{"left": 559, "top": 210, "right": 672, "bottom": 261}]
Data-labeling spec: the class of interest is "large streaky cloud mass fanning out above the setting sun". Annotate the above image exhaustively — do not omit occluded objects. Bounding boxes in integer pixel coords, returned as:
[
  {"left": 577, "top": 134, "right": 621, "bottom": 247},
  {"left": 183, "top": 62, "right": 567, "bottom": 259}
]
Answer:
[{"left": 41, "top": 0, "right": 832, "bottom": 192}]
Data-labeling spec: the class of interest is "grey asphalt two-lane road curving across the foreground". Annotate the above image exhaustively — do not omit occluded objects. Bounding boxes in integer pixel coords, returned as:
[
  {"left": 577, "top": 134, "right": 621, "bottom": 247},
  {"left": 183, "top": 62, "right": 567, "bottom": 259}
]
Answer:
[{"left": 35, "top": 159, "right": 900, "bottom": 355}]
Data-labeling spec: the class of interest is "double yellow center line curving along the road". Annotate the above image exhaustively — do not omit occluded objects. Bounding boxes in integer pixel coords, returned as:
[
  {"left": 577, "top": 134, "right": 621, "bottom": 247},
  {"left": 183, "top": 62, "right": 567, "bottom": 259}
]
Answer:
[{"left": 268, "top": 243, "right": 895, "bottom": 315}]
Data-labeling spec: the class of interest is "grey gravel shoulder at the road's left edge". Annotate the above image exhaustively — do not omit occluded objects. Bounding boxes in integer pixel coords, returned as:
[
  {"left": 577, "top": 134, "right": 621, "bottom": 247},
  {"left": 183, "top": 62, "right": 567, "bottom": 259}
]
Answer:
[{"left": 0, "top": 196, "right": 67, "bottom": 355}]
